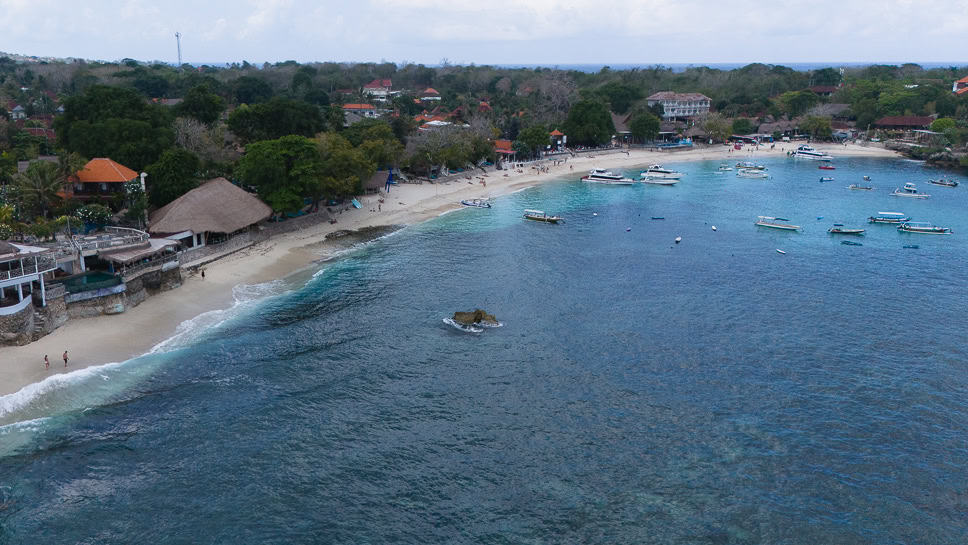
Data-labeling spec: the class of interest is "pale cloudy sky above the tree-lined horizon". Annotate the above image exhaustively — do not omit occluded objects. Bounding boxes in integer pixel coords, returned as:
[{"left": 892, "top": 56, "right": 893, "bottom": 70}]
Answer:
[{"left": 0, "top": 0, "right": 968, "bottom": 66}]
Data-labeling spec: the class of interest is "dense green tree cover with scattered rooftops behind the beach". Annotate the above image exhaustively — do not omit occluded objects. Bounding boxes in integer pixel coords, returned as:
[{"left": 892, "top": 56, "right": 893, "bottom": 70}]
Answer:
[{"left": 0, "top": 57, "right": 968, "bottom": 238}]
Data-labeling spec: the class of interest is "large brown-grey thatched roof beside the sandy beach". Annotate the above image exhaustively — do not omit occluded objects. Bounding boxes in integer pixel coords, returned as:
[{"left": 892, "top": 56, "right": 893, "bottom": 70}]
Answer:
[{"left": 148, "top": 178, "right": 272, "bottom": 233}]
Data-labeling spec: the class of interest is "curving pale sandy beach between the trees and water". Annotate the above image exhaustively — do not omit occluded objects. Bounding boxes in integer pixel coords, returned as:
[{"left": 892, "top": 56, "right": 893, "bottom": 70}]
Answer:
[{"left": 0, "top": 142, "right": 900, "bottom": 401}]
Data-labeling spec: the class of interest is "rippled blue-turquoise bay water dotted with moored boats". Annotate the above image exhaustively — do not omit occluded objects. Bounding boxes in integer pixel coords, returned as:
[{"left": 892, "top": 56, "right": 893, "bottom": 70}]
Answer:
[{"left": 0, "top": 155, "right": 968, "bottom": 544}]
